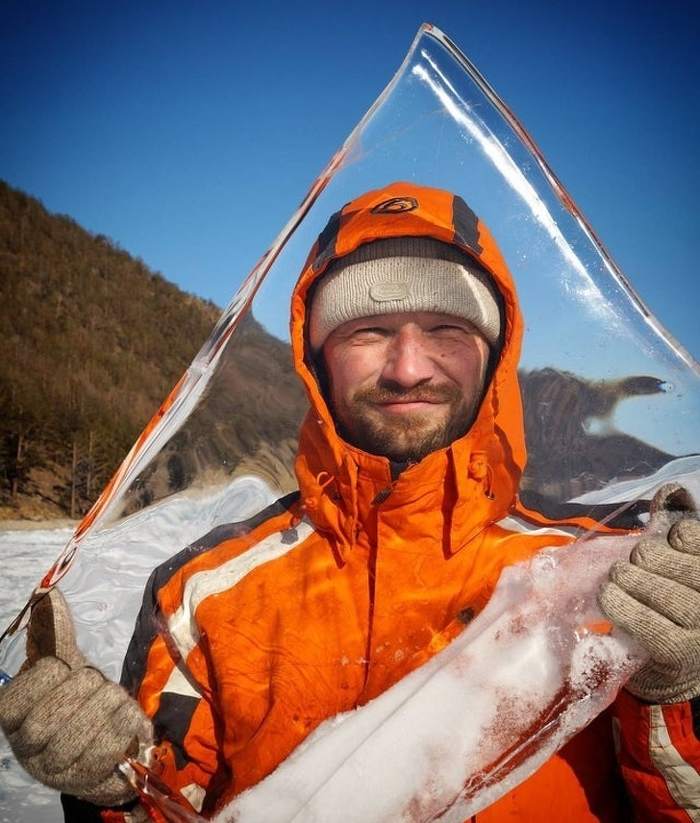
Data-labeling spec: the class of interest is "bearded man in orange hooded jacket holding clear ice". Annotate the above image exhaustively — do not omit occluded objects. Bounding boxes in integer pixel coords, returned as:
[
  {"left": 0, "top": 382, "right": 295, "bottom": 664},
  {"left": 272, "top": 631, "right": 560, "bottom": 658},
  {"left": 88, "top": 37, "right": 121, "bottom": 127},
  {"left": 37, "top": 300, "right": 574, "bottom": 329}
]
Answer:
[{"left": 0, "top": 183, "right": 700, "bottom": 823}]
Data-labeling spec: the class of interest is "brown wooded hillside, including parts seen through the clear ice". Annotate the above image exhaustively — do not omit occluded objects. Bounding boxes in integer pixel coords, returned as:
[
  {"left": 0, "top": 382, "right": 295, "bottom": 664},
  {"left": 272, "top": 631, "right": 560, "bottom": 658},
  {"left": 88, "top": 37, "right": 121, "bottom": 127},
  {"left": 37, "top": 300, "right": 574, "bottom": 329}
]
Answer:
[{"left": 0, "top": 182, "right": 670, "bottom": 519}]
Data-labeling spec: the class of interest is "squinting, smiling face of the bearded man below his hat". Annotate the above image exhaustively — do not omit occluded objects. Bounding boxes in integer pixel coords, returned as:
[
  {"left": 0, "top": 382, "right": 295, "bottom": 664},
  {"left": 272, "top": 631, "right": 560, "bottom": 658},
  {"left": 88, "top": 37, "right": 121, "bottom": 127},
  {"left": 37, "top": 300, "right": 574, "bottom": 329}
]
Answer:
[{"left": 323, "top": 312, "right": 489, "bottom": 462}]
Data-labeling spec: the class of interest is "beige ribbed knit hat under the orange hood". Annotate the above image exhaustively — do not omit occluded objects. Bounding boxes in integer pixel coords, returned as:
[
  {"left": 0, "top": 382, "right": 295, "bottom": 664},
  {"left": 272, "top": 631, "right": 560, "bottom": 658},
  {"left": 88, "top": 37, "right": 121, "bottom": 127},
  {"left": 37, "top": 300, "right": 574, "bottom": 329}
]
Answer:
[{"left": 309, "top": 237, "right": 501, "bottom": 351}]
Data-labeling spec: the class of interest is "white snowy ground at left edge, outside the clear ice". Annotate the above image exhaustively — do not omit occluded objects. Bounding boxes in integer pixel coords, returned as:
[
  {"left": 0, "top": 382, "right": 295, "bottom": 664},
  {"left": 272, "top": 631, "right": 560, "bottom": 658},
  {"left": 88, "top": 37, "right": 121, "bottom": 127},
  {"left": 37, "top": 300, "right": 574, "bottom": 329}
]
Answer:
[{"left": 0, "top": 528, "right": 71, "bottom": 823}]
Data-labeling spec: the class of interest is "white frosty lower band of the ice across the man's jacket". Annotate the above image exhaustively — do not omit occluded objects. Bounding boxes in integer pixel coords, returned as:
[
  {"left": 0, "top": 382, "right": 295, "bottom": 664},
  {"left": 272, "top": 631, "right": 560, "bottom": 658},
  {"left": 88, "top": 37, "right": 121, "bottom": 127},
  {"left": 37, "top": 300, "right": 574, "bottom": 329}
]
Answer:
[{"left": 216, "top": 535, "right": 643, "bottom": 823}]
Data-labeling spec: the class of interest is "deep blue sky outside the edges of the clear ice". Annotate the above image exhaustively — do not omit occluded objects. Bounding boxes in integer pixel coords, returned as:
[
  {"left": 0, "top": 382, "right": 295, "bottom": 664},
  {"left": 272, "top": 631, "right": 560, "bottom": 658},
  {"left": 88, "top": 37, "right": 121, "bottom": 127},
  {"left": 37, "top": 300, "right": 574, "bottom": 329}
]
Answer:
[{"left": 0, "top": 0, "right": 700, "bottom": 359}]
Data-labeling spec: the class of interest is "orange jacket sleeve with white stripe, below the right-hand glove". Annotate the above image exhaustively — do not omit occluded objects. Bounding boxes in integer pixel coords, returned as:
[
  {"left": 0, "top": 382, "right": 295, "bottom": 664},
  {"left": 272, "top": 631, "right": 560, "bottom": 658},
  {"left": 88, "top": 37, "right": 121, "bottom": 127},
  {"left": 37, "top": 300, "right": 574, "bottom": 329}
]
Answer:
[{"left": 613, "top": 690, "right": 700, "bottom": 823}]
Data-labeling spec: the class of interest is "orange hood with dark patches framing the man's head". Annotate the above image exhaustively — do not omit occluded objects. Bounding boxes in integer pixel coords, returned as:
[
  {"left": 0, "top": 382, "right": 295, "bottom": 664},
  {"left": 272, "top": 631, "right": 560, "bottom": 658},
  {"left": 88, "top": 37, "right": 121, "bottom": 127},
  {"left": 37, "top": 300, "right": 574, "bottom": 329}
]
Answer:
[{"left": 291, "top": 182, "right": 526, "bottom": 558}]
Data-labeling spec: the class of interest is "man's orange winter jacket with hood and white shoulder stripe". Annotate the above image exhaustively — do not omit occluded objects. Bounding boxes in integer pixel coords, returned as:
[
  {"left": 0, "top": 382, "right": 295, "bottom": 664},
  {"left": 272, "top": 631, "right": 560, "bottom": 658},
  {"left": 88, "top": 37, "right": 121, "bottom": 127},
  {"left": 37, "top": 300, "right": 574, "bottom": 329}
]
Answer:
[{"left": 116, "top": 183, "right": 700, "bottom": 823}]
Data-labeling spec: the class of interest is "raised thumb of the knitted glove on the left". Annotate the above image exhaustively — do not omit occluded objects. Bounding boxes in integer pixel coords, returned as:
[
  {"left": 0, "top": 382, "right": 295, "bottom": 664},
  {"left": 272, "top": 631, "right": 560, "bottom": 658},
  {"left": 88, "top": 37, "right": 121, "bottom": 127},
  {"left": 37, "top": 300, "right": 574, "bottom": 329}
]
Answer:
[{"left": 26, "top": 588, "right": 86, "bottom": 669}]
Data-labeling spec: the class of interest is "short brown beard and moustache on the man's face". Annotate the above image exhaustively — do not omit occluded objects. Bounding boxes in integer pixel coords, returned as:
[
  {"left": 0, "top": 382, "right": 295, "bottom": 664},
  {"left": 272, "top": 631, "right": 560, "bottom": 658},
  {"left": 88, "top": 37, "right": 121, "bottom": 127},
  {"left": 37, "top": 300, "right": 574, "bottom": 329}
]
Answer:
[{"left": 334, "top": 383, "right": 479, "bottom": 463}]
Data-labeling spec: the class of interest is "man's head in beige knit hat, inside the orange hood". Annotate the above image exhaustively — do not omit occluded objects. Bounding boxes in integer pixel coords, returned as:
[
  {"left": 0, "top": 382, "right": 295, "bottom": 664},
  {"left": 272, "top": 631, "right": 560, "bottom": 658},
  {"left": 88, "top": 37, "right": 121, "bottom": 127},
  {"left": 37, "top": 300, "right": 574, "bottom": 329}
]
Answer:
[{"left": 309, "top": 237, "right": 501, "bottom": 463}]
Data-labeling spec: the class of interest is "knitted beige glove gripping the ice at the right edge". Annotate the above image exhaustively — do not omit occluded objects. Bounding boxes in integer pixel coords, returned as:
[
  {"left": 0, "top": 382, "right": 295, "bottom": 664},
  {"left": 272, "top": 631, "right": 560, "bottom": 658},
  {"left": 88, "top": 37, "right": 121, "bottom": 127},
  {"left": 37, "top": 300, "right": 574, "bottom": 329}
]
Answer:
[{"left": 598, "top": 484, "right": 700, "bottom": 703}]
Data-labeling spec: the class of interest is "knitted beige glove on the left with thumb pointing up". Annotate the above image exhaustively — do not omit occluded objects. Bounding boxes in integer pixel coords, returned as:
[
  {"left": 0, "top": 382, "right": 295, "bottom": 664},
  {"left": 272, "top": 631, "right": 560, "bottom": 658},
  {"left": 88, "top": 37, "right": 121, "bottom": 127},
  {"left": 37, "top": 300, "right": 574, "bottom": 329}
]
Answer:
[{"left": 0, "top": 589, "right": 152, "bottom": 806}]
